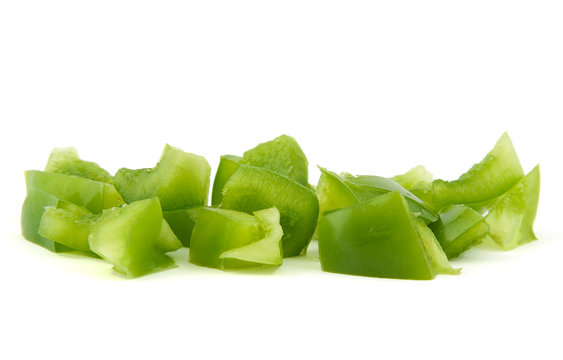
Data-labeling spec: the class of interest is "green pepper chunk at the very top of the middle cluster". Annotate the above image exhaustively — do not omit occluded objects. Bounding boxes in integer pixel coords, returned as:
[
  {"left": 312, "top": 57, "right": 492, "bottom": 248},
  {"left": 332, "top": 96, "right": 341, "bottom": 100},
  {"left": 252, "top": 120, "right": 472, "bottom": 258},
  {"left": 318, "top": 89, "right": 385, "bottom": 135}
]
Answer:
[{"left": 243, "top": 135, "right": 309, "bottom": 186}]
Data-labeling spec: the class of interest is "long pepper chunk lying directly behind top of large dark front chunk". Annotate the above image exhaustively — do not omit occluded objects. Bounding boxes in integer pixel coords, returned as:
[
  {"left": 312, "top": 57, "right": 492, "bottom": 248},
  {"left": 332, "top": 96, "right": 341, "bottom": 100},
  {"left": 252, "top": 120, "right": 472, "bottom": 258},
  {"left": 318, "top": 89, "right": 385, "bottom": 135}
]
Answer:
[{"left": 317, "top": 168, "right": 437, "bottom": 222}]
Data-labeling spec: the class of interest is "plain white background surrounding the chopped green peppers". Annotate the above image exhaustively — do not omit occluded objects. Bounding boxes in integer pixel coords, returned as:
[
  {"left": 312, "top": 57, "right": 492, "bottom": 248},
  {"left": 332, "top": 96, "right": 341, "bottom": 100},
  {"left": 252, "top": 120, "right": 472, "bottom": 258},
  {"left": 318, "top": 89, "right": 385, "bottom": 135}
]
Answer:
[{"left": 0, "top": 0, "right": 563, "bottom": 359}]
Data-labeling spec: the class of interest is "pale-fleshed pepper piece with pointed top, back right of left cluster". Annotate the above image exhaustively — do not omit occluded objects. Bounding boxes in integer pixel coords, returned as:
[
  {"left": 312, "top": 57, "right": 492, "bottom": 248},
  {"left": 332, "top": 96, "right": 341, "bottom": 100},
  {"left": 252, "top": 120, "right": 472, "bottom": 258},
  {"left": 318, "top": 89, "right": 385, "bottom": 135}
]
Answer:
[{"left": 114, "top": 144, "right": 211, "bottom": 211}]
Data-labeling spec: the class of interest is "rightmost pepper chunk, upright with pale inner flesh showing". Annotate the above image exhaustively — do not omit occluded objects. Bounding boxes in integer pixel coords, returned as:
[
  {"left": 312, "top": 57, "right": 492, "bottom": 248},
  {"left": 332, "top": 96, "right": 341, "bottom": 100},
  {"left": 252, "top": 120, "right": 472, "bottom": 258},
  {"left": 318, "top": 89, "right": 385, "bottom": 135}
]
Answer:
[{"left": 485, "top": 165, "right": 540, "bottom": 250}]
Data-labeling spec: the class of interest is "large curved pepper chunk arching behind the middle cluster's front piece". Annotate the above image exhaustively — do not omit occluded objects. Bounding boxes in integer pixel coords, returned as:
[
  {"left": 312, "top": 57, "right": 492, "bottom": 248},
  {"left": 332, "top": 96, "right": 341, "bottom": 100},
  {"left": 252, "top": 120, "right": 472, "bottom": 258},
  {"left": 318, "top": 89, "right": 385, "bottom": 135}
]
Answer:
[{"left": 219, "top": 165, "right": 319, "bottom": 257}]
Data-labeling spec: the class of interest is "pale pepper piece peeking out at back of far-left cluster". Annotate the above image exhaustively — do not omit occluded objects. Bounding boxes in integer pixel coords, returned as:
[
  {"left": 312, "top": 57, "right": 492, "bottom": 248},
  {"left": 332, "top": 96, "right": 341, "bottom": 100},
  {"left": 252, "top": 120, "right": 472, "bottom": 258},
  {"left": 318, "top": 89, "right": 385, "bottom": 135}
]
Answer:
[{"left": 45, "top": 148, "right": 113, "bottom": 184}]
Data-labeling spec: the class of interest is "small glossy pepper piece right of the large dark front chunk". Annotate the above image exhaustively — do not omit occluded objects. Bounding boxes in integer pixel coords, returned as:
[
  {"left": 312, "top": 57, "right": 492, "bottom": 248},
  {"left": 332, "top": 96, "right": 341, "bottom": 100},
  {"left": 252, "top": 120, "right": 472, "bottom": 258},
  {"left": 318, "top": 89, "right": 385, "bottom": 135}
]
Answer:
[{"left": 430, "top": 204, "right": 489, "bottom": 259}]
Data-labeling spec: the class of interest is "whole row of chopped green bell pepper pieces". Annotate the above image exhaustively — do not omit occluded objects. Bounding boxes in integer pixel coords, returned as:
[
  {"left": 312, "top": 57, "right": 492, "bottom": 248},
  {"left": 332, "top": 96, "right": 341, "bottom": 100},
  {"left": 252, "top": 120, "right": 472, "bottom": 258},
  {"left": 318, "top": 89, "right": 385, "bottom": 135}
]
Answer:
[{"left": 21, "top": 133, "right": 540, "bottom": 280}]
